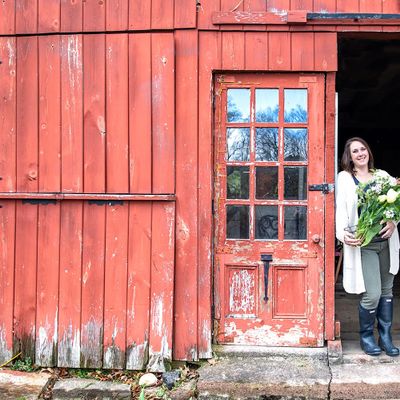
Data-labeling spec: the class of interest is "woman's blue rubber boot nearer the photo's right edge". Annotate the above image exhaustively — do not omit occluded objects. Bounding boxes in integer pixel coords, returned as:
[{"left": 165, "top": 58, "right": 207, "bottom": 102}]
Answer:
[{"left": 377, "top": 297, "right": 399, "bottom": 357}]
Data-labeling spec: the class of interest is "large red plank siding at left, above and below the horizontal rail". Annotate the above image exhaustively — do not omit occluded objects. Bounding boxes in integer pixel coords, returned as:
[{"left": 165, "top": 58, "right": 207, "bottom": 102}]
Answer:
[{"left": 0, "top": 33, "right": 176, "bottom": 371}]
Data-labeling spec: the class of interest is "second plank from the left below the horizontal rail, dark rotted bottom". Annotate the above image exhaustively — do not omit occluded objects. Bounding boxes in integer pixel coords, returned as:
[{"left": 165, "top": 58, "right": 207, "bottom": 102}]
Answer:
[{"left": 13, "top": 201, "right": 38, "bottom": 361}]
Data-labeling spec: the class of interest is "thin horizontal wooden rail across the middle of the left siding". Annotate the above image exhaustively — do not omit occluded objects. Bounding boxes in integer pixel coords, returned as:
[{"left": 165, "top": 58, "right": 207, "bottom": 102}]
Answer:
[{"left": 0, "top": 192, "right": 176, "bottom": 201}]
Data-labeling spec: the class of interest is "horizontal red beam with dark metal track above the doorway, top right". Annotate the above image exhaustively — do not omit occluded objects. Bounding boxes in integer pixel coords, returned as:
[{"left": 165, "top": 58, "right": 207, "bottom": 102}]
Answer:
[{"left": 212, "top": 10, "right": 400, "bottom": 25}]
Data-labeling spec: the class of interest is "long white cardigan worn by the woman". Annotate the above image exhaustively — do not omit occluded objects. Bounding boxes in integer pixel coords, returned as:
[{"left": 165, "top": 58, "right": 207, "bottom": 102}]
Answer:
[{"left": 336, "top": 171, "right": 399, "bottom": 294}]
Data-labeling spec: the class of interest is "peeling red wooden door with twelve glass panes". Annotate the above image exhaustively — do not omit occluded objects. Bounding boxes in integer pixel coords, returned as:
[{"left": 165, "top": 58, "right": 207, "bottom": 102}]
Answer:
[{"left": 214, "top": 74, "right": 324, "bottom": 346}]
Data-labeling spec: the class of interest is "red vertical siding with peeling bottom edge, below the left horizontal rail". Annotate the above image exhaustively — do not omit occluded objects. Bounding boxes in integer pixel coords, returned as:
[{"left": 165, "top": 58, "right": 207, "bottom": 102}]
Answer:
[{"left": 0, "top": 200, "right": 175, "bottom": 371}]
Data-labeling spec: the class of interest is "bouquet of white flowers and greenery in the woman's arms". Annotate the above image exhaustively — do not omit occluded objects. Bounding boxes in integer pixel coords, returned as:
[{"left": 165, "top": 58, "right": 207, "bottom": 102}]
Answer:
[{"left": 356, "top": 170, "right": 400, "bottom": 246}]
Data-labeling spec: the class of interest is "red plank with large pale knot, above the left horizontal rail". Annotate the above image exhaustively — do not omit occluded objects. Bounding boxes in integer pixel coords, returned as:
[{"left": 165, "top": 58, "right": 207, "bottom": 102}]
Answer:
[{"left": 83, "top": 34, "right": 106, "bottom": 193}]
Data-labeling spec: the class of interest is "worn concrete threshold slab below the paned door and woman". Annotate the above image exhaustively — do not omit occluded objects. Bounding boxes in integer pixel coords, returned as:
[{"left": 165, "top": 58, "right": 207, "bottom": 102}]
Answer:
[{"left": 197, "top": 342, "right": 400, "bottom": 400}]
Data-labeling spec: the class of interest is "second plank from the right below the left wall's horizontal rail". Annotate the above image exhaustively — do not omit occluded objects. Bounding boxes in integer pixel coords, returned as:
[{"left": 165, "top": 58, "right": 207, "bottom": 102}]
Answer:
[{"left": 126, "top": 202, "right": 152, "bottom": 370}]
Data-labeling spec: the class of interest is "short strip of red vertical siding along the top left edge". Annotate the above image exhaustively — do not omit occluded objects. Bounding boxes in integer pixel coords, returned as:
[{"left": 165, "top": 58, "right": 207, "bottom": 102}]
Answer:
[{"left": 0, "top": 0, "right": 197, "bottom": 35}]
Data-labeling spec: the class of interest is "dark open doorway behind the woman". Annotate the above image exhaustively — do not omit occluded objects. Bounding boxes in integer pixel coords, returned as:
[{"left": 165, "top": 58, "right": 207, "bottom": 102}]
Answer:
[{"left": 335, "top": 33, "right": 400, "bottom": 345}]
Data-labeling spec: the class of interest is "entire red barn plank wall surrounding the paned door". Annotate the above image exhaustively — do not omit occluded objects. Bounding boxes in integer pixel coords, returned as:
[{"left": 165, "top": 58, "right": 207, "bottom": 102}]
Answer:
[{"left": 0, "top": 0, "right": 399, "bottom": 370}]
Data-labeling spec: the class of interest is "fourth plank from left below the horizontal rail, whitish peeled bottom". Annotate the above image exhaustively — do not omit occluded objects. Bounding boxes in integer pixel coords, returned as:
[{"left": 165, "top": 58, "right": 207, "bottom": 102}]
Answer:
[{"left": 57, "top": 200, "right": 83, "bottom": 368}]
